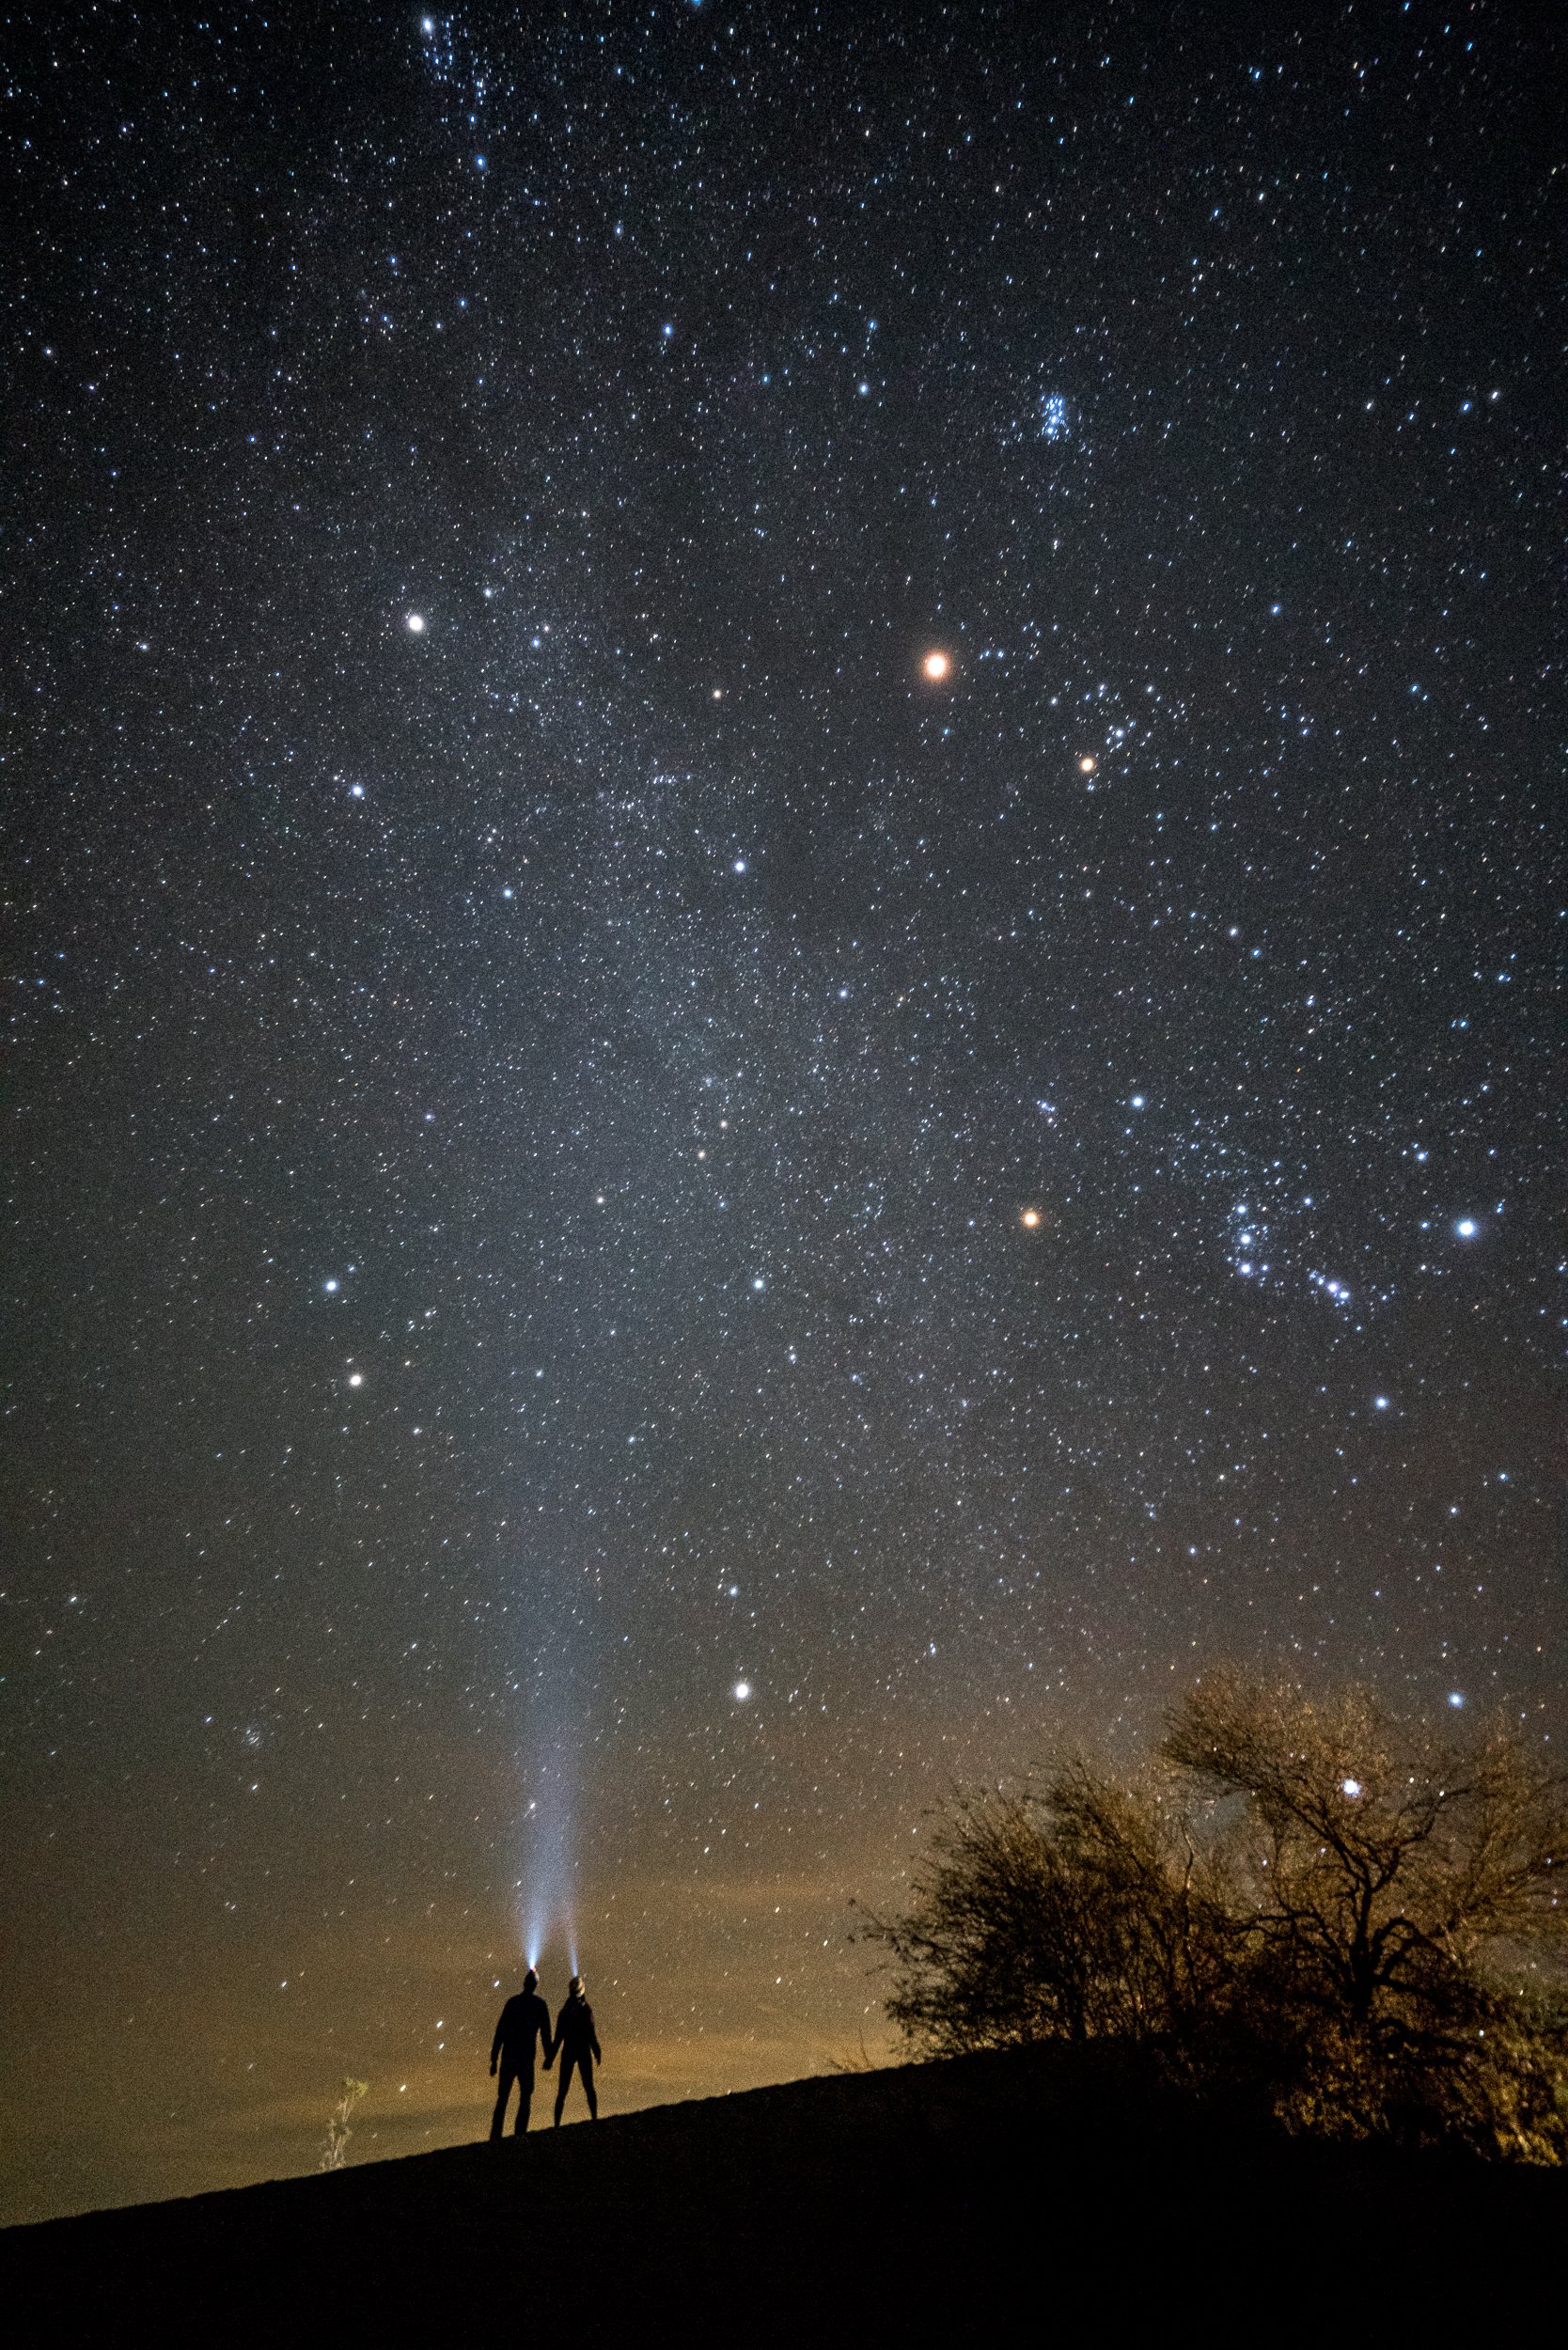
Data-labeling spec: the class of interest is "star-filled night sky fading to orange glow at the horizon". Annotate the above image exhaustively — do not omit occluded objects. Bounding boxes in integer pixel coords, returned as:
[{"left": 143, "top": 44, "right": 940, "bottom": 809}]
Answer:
[{"left": 0, "top": 0, "right": 1565, "bottom": 2218}]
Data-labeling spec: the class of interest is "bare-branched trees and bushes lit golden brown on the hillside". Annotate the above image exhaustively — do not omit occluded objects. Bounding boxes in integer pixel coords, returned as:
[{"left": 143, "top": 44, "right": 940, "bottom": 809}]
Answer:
[{"left": 868, "top": 1673, "right": 1568, "bottom": 2162}]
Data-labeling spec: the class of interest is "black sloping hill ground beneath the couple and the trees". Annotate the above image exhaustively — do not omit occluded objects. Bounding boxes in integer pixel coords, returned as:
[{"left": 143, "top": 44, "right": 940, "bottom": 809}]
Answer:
[{"left": 0, "top": 2049, "right": 1568, "bottom": 2345}]
